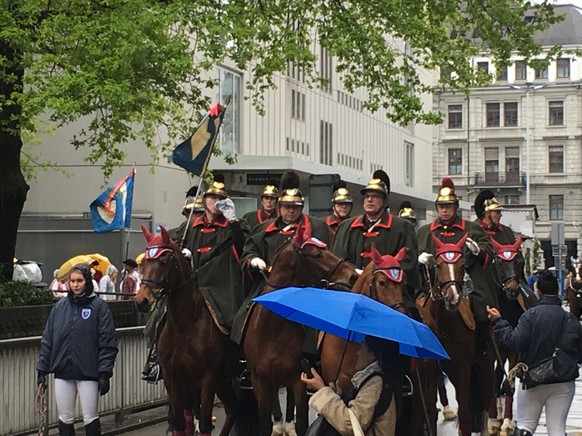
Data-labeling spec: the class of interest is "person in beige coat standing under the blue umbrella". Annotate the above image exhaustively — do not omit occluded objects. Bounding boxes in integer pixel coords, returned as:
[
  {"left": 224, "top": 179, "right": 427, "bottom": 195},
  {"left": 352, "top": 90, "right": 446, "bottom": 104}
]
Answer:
[{"left": 301, "top": 336, "right": 402, "bottom": 436}]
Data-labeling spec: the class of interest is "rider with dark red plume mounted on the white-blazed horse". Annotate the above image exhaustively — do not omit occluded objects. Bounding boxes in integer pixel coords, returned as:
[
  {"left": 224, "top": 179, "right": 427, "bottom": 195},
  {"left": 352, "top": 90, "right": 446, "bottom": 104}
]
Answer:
[{"left": 418, "top": 178, "right": 498, "bottom": 352}]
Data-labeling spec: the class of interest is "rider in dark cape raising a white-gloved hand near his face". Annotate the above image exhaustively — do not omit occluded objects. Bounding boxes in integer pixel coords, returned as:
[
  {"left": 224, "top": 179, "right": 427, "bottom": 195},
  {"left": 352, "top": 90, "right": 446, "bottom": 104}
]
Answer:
[{"left": 142, "top": 174, "right": 248, "bottom": 382}]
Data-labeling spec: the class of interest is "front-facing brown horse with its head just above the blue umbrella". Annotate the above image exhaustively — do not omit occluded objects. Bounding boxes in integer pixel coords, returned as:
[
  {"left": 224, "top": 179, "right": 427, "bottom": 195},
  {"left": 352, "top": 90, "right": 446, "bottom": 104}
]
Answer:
[{"left": 321, "top": 245, "right": 437, "bottom": 435}]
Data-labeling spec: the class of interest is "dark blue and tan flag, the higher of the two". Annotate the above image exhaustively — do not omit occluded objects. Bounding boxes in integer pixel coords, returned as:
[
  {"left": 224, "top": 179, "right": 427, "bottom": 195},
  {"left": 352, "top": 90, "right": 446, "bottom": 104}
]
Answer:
[{"left": 172, "top": 103, "right": 226, "bottom": 177}]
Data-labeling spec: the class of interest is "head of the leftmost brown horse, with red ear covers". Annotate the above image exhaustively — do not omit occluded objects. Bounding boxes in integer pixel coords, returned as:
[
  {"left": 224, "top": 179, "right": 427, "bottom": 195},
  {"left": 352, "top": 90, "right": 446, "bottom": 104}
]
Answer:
[{"left": 135, "top": 225, "right": 192, "bottom": 312}]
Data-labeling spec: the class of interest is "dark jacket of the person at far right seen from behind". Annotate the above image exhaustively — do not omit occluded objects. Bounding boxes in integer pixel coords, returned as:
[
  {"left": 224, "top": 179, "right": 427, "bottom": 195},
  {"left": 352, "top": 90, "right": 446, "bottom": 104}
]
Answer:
[{"left": 493, "top": 295, "right": 582, "bottom": 372}]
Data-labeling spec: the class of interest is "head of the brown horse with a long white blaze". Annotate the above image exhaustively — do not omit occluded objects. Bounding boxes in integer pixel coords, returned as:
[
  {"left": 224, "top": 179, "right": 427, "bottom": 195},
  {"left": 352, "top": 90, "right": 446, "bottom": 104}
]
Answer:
[{"left": 431, "top": 233, "right": 469, "bottom": 311}]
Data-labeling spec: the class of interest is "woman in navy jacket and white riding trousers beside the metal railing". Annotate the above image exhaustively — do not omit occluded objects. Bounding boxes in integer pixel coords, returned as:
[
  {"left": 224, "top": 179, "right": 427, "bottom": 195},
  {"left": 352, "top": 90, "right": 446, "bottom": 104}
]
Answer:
[{"left": 36, "top": 264, "right": 118, "bottom": 436}]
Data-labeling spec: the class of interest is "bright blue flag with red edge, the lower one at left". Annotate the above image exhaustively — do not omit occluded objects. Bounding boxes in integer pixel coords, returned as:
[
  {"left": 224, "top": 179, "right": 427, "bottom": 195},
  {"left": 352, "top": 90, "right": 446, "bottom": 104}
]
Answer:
[{"left": 89, "top": 168, "right": 135, "bottom": 233}]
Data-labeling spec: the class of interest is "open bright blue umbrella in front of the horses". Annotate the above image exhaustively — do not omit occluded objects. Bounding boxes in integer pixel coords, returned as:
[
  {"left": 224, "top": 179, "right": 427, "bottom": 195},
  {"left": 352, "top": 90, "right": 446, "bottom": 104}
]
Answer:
[{"left": 253, "top": 287, "right": 449, "bottom": 359}]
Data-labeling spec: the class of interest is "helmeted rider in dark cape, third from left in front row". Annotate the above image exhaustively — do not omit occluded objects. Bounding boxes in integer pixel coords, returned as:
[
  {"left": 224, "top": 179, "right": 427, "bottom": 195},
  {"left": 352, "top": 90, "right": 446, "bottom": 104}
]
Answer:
[{"left": 331, "top": 170, "right": 420, "bottom": 308}]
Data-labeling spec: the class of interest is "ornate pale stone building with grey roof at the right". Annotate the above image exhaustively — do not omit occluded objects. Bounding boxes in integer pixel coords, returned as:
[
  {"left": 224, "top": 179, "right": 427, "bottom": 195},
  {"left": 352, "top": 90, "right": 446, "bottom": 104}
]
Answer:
[{"left": 433, "top": 5, "right": 582, "bottom": 266}]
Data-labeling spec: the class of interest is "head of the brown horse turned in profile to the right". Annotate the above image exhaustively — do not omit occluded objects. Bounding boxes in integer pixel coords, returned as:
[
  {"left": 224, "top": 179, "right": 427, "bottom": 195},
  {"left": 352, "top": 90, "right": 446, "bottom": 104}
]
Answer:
[{"left": 268, "top": 225, "right": 358, "bottom": 289}]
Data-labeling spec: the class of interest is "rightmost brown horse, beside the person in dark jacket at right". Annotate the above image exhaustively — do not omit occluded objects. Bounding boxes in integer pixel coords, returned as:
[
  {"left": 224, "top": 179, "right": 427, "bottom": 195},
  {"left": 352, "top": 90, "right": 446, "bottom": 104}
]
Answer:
[{"left": 488, "top": 236, "right": 526, "bottom": 436}]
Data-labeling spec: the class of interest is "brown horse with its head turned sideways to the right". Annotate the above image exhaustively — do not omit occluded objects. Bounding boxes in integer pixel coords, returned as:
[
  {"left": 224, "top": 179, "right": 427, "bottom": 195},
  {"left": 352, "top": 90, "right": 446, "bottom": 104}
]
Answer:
[{"left": 243, "top": 223, "right": 358, "bottom": 436}]
